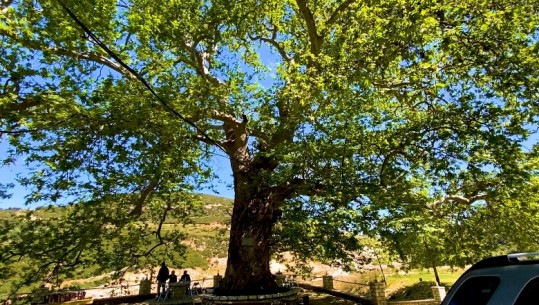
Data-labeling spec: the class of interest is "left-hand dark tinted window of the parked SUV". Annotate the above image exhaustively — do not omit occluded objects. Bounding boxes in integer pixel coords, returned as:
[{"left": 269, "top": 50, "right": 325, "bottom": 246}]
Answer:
[{"left": 449, "top": 276, "right": 500, "bottom": 305}]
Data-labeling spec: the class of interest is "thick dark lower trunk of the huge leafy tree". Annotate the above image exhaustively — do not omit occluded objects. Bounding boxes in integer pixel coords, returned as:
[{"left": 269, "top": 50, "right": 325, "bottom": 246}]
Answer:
[{"left": 218, "top": 164, "right": 277, "bottom": 295}]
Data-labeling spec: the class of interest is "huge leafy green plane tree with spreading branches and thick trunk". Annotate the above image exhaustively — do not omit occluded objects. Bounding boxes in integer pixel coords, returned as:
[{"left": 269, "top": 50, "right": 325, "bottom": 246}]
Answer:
[{"left": 0, "top": 0, "right": 539, "bottom": 293}]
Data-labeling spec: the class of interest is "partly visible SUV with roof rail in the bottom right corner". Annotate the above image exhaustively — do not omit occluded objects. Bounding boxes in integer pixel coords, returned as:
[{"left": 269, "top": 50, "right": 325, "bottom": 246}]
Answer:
[{"left": 442, "top": 252, "right": 539, "bottom": 305}]
